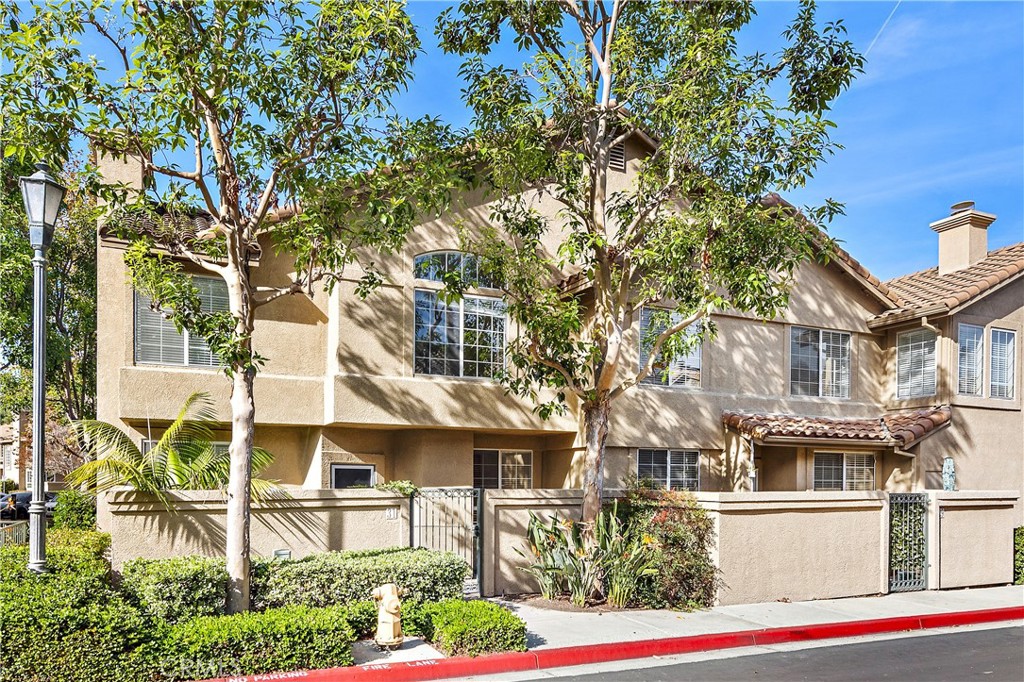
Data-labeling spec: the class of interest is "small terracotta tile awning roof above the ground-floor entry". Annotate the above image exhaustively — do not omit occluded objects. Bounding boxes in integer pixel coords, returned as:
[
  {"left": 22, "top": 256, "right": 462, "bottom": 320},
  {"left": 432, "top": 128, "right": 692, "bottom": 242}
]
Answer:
[{"left": 722, "top": 406, "right": 951, "bottom": 447}]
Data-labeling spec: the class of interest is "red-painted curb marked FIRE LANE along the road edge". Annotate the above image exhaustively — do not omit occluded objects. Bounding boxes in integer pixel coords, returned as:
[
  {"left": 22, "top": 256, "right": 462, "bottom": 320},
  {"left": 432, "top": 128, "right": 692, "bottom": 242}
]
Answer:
[{"left": 193, "top": 606, "right": 1024, "bottom": 682}]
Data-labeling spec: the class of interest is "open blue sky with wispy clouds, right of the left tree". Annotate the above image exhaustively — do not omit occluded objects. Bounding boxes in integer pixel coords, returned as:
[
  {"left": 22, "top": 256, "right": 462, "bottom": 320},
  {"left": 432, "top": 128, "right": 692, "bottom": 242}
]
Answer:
[{"left": 398, "top": 0, "right": 1024, "bottom": 280}]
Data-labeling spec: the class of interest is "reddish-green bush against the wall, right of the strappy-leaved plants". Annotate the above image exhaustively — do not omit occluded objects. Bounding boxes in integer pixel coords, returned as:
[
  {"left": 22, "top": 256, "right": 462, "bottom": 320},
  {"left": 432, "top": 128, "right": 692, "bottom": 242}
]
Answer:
[{"left": 616, "top": 481, "right": 720, "bottom": 608}]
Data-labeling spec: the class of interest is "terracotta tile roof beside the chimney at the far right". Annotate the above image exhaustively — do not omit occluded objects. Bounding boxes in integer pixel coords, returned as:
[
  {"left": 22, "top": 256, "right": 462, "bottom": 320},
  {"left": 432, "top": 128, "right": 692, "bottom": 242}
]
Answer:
[{"left": 873, "top": 242, "right": 1024, "bottom": 322}]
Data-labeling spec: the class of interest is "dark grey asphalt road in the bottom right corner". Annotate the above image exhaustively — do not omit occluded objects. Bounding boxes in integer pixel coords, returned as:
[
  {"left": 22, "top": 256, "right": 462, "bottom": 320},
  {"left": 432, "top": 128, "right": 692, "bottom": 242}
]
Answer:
[{"left": 562, "top": 627, "right": 1024, "bottom": 682}]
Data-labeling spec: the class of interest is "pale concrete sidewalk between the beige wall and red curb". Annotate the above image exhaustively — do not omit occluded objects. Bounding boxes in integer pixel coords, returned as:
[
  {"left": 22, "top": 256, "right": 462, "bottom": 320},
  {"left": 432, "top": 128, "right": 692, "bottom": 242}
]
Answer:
[{"left": 501, "top": 586, "right": 1024, "bottom": 650}]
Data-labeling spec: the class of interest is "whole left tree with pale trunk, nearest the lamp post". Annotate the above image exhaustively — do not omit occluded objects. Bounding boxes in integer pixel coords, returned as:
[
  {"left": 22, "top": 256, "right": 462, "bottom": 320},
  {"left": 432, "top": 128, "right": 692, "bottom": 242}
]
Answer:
[{"left": 0, "top": 0, "right": 453, "bottom": 611}]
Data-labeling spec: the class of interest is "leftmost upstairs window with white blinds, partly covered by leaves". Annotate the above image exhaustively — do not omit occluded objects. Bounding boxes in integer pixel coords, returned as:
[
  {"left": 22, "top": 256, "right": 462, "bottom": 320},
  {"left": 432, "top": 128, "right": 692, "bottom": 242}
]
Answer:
[{"left": 135, "top": 275, "right": 228, "bottom": 367}]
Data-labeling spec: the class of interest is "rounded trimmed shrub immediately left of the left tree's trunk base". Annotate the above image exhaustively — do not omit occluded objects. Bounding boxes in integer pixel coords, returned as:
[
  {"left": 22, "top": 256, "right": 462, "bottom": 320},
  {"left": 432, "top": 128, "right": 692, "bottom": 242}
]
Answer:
[{"left": 121, "top": 556, "right": 227, "bottom": 623}]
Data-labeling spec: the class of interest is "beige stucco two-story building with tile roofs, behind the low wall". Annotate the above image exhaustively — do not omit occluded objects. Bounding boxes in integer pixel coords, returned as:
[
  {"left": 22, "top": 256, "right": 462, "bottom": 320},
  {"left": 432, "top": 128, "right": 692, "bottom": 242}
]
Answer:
[{"left": 97, "top": 147, "right": 1024, "bottom": 520}]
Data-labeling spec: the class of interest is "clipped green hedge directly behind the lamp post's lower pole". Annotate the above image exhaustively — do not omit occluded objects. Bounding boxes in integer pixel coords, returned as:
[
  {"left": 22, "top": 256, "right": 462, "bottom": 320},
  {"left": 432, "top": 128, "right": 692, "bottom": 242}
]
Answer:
[{"left": 0, "top": 528, "right": 111, "bottom": 585}]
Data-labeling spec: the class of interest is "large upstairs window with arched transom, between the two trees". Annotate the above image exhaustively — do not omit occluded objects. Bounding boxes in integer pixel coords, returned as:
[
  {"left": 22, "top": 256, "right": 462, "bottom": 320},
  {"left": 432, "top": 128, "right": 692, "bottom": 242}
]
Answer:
[{"left": 413, "top": 251, "right": 506, "bottom": 377}]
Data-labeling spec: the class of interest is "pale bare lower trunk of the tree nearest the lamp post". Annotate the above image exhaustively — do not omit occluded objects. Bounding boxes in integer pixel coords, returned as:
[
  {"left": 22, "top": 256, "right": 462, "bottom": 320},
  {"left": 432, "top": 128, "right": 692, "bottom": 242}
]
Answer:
[{"left": 226, "top": 360, "right": 256, "bottom": 613}]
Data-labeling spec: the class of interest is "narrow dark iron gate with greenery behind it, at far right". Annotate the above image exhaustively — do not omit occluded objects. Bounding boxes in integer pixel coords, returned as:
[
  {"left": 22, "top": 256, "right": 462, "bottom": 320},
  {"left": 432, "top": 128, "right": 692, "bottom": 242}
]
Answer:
[{"left": 889, "top": 493, "right": 928, "bottom": 592}]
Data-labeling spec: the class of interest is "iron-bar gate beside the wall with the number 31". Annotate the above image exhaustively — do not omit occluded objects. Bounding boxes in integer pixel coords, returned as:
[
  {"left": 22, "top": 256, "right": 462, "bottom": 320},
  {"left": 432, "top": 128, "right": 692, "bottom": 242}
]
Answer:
[{"left": 409, "top": 487, "right": 483, "bottom": 581}]
